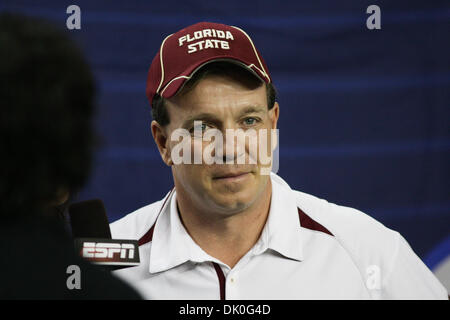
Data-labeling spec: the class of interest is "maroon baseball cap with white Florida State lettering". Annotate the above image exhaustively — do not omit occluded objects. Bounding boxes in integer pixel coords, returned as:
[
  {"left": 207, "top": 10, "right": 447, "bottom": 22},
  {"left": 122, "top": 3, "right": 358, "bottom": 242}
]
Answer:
[{"left": 146, "top": 22, "right": 271, "bottom": 105}]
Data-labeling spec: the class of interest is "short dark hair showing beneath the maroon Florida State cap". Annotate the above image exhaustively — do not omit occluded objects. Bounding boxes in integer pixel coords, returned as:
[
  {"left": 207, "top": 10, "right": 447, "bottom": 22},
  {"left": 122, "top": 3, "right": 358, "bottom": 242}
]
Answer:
[{"left": 152, "top": 61, "right": 277, "bottom": 126}]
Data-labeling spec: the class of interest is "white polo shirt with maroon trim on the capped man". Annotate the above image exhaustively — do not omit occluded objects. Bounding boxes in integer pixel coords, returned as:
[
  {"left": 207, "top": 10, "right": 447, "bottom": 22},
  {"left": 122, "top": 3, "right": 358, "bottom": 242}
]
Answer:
[{"left": 111, "top": 174, "right": 448, "bottom": 300}]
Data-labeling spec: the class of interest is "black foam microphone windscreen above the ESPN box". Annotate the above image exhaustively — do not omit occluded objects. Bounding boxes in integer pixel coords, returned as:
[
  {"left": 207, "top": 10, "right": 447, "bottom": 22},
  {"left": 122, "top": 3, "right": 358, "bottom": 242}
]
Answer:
[{"left": 69, "top": 199, "right": 111, "bottom": 239}]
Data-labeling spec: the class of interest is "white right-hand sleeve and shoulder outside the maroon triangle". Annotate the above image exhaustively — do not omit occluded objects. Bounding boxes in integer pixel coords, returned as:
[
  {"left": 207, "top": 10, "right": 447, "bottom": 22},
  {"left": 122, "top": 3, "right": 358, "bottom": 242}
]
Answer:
[{"left": 293, "top": 191, "right": 447, "bottom": 299}]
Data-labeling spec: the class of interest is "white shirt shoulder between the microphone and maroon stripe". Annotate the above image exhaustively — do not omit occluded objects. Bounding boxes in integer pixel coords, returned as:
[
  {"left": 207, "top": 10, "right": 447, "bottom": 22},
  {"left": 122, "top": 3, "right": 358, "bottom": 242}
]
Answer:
[{"left": 110, "top": 195, "right": 164, "bottom": 240}]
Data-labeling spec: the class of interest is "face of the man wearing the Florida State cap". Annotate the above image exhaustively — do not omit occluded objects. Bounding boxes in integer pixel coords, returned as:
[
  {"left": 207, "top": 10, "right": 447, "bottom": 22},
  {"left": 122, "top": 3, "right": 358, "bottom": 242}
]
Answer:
[{"left": 156, "top": 75, "right": 279, "bottom": 215}]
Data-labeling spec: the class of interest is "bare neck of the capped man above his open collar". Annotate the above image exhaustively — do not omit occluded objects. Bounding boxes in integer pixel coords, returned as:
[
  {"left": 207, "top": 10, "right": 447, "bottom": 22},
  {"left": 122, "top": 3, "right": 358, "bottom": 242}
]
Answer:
[{"left": 177, "top": 179, "right": 272, "bottom": 268}]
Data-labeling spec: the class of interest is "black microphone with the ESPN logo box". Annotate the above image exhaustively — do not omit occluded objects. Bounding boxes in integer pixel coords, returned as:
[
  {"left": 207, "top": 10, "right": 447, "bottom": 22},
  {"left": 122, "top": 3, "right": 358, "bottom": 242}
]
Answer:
[{"left": 69, "top": 199, "right": 140, "bottom": 270}]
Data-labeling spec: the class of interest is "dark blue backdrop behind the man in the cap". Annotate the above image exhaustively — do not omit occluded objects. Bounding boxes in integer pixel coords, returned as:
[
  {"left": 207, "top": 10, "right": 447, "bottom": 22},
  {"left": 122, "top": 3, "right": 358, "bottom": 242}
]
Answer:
[{"left": 0, "top": 0, "right": 450, "bottom": 267}]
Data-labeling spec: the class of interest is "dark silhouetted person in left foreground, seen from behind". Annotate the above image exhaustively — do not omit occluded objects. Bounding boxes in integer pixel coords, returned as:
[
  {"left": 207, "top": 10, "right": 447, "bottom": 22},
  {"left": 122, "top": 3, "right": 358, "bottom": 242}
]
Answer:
[{"left": 0, "top": 14, "right": 140, "bottom": 299}]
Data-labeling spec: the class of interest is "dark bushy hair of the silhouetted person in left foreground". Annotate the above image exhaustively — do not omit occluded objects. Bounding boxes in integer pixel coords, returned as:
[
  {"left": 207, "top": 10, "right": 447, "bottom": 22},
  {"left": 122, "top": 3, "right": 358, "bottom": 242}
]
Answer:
[{"left": 0, "top": 14, "right": 95, "bottom": 215}]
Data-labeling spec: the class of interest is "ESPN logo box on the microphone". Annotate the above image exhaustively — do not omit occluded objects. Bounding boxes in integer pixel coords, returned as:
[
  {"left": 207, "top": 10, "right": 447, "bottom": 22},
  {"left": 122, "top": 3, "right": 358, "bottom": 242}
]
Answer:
[{"left": 75, "top": 238, "right": 139, "bottom": 269}]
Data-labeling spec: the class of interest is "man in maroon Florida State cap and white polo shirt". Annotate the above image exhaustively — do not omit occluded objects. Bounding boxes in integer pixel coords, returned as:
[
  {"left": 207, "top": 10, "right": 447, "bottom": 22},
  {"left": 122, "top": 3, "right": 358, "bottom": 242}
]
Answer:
[{"left": 111, "top": 22, "right": 447, "bottom": 299}]
